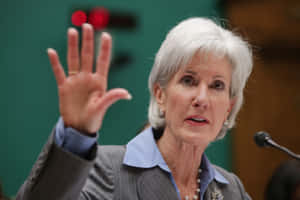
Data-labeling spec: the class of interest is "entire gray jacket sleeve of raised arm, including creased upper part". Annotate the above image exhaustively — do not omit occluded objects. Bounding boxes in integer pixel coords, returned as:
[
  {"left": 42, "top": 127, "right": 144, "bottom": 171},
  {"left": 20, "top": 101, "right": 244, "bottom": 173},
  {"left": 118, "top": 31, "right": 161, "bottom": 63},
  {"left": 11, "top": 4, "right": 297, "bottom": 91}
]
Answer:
[{"left": 16, "top": 131, "right": 113, "bottom": 200}]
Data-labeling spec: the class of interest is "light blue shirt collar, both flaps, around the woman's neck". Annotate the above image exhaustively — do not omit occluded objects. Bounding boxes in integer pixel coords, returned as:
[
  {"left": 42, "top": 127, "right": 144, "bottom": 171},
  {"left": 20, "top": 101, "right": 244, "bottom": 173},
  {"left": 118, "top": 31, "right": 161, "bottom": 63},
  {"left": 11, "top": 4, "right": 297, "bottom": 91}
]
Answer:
[{"left": 123, "top": 127, "right": 229, "bottom": 184}]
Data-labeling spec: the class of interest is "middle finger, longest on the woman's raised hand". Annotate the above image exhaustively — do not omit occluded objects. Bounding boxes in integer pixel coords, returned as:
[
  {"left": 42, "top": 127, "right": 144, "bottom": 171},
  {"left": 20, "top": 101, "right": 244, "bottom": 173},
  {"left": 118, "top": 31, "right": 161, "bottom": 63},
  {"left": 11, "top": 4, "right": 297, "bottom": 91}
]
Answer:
[{"left": 81, "top": 24, "right": 94, "bottom": 72}]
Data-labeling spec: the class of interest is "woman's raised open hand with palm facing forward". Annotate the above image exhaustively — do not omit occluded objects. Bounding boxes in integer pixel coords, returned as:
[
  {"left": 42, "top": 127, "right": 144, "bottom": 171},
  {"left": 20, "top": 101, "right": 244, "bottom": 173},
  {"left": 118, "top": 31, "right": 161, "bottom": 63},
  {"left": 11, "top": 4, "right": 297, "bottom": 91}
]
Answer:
[{"left": 48, "top": 24, "right": 131, "bottom": 134}]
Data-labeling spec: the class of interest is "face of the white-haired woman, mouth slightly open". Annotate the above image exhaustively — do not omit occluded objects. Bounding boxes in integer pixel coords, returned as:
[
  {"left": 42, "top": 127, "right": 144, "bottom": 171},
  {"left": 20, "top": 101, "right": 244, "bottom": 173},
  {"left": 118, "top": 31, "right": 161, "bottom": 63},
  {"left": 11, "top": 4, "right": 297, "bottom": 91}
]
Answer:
[{"left": 155, "top": 53, "right": 234, "bottom": 147}]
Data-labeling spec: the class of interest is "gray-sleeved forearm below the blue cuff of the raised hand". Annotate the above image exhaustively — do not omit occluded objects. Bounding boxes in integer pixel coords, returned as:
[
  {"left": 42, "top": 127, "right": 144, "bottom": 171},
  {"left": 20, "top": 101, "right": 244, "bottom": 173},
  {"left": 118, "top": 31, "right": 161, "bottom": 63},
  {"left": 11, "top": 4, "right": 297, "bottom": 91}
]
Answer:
[{"left": 17, "top": 127, "right": 97, "bottom": 200}]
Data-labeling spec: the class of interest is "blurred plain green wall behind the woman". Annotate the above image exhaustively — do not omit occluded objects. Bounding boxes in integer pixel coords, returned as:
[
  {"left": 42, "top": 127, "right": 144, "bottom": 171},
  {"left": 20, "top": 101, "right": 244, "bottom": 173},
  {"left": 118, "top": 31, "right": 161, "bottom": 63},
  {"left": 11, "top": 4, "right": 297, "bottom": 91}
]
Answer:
[{"left": 0, "top": 0, "right": 231, "bottom": 196}]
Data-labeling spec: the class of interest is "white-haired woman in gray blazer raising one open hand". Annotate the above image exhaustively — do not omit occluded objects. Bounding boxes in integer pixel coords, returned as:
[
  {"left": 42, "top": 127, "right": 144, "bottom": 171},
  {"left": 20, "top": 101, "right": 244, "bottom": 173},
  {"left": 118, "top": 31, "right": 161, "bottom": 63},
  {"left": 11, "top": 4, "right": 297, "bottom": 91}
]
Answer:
[{"left": 17, "top": 18, "right": 252, "bottom": 200}]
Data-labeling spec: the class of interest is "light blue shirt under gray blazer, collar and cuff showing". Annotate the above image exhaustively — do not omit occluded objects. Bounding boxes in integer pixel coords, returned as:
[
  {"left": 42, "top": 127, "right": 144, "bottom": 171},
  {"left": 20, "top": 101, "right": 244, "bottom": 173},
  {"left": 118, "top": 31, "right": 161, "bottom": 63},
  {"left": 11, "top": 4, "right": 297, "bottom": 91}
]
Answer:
[{"left": 55, "top": 118, "right": 229, "bottom": 200}]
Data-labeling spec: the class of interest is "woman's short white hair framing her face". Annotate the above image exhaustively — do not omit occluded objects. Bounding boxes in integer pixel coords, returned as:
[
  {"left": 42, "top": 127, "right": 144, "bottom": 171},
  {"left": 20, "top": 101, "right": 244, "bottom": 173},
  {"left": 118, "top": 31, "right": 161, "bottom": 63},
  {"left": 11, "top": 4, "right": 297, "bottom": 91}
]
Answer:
[{"left": 148, "top": 17, "right": 253, "bottom": 139}]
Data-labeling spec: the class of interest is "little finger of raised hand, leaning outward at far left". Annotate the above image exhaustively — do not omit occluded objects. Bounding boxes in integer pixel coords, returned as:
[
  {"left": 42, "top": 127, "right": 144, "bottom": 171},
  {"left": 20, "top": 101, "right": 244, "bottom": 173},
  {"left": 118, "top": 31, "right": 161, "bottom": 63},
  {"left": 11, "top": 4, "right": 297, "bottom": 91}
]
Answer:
[{"left": 47, "top": 48, "right": 66, "bottom": 86}]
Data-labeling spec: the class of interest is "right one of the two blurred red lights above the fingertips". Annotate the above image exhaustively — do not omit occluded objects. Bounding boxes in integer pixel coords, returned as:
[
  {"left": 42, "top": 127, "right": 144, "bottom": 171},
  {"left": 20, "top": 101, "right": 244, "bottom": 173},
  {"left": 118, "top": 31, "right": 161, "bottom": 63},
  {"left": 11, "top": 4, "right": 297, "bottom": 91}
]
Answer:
[{"left": 88, "top": 7, "right": 109, "bottom": 30}]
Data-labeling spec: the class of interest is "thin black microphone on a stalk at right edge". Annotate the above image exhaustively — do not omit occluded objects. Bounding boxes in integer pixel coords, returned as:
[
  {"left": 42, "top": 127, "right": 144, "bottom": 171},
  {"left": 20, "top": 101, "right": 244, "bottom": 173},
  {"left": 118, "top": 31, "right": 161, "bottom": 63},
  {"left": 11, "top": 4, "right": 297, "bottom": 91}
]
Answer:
[{"left": 254, "top": 131, "right": 300, "bottom": 160}]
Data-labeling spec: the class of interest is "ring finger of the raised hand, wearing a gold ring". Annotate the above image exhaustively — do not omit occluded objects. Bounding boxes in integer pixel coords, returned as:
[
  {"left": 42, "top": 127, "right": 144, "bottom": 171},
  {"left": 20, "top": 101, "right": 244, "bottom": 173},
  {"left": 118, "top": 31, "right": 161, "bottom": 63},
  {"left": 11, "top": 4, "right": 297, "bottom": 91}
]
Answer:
[{"left": 67, "top": 28, "right": 79, "bottom": 75}]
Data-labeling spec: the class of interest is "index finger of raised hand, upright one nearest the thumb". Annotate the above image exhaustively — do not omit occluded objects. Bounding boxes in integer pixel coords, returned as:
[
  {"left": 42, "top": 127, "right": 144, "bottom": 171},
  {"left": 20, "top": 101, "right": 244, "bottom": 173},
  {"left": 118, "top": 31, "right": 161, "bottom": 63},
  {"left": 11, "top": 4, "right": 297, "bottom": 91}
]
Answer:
[{"left": 96, "top": 32, "right": 112, "bottom": 79}]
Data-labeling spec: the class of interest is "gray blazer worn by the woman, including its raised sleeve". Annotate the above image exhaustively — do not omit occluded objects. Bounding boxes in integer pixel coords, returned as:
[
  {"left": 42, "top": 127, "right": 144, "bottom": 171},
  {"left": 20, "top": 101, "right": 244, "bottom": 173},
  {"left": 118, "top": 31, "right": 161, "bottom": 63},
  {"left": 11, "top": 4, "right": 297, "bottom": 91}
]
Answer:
[{"left": 16, "top": 130, "right": 250, "bottom": 200}]
